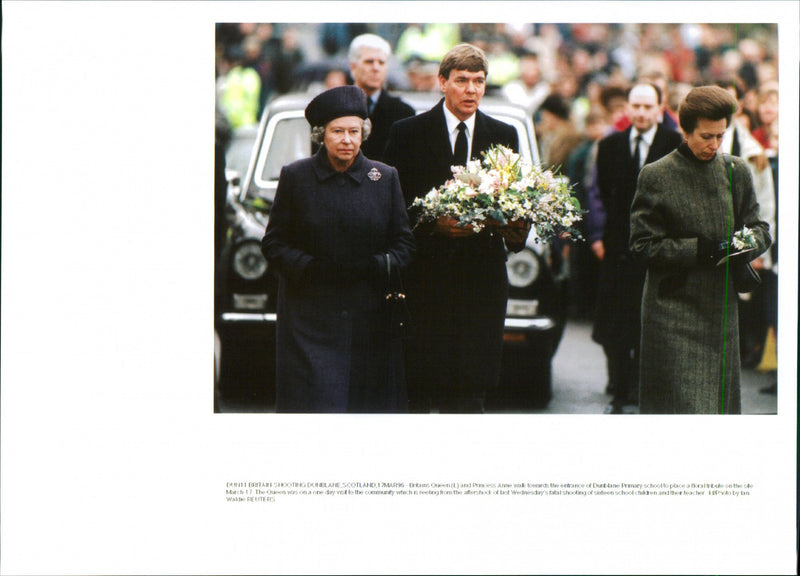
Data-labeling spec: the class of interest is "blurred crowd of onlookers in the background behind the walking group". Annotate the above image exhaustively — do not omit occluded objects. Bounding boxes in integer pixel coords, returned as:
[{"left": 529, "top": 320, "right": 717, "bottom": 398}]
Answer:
[{"left": 216, "top": 23, "right": 778, "bottom": 382}]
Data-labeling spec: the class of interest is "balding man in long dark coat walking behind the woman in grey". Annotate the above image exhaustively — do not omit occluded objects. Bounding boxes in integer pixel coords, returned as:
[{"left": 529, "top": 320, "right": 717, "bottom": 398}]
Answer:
[{"left": 592, "top": 83, "right": 682, "bottom": 414}]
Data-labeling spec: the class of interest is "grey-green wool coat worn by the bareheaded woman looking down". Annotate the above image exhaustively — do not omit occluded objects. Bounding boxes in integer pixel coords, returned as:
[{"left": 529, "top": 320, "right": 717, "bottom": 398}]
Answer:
[{"left": 630, "top": 144, "right": 771, "bottom": 414}]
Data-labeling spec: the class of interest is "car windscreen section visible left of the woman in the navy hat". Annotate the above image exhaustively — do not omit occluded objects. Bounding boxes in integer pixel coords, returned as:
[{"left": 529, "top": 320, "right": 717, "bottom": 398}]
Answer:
[{"left": 254, "top": 110, "right": 311, "bottom": 189}]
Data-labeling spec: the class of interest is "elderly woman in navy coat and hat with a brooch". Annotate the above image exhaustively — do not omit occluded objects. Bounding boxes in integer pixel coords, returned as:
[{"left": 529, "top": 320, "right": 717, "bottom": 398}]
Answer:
[{"left": 262, "top": 86, "right": 414, "bottom": 412}]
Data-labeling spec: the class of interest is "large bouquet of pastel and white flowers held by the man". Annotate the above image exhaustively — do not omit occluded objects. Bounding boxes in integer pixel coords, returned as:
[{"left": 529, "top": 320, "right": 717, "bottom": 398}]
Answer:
[{"left": 412, "top": 145, "right": 581, "bottom": 239}]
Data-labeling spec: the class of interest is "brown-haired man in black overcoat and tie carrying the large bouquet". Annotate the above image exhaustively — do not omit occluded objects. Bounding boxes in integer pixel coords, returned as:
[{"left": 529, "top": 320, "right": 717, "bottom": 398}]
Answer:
[{"left": 384, "top": 44, "right": 527, "bottom": 413}]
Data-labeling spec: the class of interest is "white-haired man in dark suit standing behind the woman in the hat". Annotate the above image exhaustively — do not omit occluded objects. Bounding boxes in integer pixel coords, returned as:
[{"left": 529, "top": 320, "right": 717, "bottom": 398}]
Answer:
[{"left": 348, "top": 34, "right": 414, "bottom": 161}]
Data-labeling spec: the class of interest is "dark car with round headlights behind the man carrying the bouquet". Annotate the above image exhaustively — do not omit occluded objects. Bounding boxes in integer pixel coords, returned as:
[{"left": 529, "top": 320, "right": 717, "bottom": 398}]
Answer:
[{"left": 215, "top": 93, "right": 566, "bottom": 412}]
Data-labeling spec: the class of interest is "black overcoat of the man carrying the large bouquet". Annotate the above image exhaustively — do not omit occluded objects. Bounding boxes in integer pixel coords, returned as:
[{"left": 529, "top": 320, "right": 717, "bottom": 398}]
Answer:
[{"left": 384, "top": 99, "right": 519, "bottom": 400}]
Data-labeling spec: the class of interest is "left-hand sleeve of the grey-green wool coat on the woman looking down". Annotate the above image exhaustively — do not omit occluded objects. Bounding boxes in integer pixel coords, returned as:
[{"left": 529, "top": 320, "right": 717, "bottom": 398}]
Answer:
[{"left": 630, "top": 165, "right": 697, "bottom": 268}]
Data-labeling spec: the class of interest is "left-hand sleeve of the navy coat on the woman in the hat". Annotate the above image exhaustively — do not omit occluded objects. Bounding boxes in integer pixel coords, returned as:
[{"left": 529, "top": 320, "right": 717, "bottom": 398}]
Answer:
[{"left": 261, "top": 167, "right": 313, "bottom": 281}]
